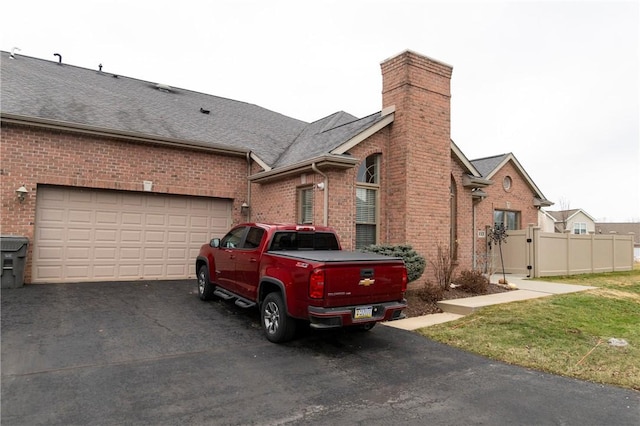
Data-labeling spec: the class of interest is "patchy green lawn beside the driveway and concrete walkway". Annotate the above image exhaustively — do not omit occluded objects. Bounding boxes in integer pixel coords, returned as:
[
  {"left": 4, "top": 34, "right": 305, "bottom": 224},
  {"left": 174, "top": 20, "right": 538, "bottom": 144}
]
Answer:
[{"left": 419, "top": 267, "right": 640, "bottom": 390}]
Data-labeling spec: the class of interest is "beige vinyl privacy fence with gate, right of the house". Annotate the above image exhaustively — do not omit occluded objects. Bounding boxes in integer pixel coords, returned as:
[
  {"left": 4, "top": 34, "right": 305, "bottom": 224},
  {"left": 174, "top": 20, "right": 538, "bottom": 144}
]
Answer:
[{"left": 493, "top": 226, "right": 633, "bottom": 277}]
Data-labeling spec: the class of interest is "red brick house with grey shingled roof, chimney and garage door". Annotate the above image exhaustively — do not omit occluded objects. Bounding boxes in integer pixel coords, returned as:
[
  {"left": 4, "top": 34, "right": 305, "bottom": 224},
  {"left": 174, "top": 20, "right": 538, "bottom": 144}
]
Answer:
[{"left": 0, "top": 51, "right": 550, "bottom": 283}]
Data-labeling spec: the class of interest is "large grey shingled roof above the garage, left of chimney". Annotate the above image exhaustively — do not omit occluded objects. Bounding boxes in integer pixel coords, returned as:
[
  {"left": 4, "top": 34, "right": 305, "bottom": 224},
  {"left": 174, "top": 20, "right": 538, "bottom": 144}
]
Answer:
[{"left": 1, "top": 52, "right": 380, "bottom": 168}]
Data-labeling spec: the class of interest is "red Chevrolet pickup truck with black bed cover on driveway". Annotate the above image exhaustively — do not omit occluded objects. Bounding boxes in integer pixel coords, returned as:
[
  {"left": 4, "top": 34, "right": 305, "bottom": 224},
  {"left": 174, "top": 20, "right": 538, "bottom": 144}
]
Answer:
[{"left": 196, "top": 223, "right": 407, "bottom": 343}]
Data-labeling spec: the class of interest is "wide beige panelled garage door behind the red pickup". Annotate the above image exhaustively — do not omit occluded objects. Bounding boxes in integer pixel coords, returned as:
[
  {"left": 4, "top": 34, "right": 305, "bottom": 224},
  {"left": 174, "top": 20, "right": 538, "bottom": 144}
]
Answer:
[{"left": 32, "top": 187, "right": 231, "bottom": 283}]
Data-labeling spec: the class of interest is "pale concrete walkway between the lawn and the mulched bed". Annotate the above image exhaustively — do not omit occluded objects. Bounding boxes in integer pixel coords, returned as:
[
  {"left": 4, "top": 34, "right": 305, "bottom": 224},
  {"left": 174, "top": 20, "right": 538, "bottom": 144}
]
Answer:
[{"left": 383, "top": 275, "right": 595, "bottom": 330}]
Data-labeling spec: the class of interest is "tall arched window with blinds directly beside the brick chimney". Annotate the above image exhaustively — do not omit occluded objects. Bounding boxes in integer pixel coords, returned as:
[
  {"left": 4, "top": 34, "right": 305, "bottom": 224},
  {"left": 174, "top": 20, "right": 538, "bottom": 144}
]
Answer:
[{"left": 356, "top": 154, "right": 380, "bottom": 249}]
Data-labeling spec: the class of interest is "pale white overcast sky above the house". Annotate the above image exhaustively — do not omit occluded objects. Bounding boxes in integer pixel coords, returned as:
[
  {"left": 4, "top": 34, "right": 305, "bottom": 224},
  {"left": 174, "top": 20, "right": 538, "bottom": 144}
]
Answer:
[{"left": 0, "top": 0, "right": 640, "bottom": 222}]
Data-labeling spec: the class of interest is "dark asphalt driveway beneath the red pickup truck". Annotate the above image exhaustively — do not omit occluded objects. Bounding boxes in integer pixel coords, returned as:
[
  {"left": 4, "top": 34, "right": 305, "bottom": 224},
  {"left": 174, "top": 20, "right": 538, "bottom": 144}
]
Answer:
[{"left": 1, "top": 280, "right": 640, "bottom": 426}]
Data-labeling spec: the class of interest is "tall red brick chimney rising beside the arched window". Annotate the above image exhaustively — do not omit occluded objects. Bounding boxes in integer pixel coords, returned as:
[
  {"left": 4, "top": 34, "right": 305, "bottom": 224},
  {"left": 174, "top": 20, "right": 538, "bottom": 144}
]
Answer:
[{"left": 380, "top": 51, "right": 453, "bottom": 266}]
